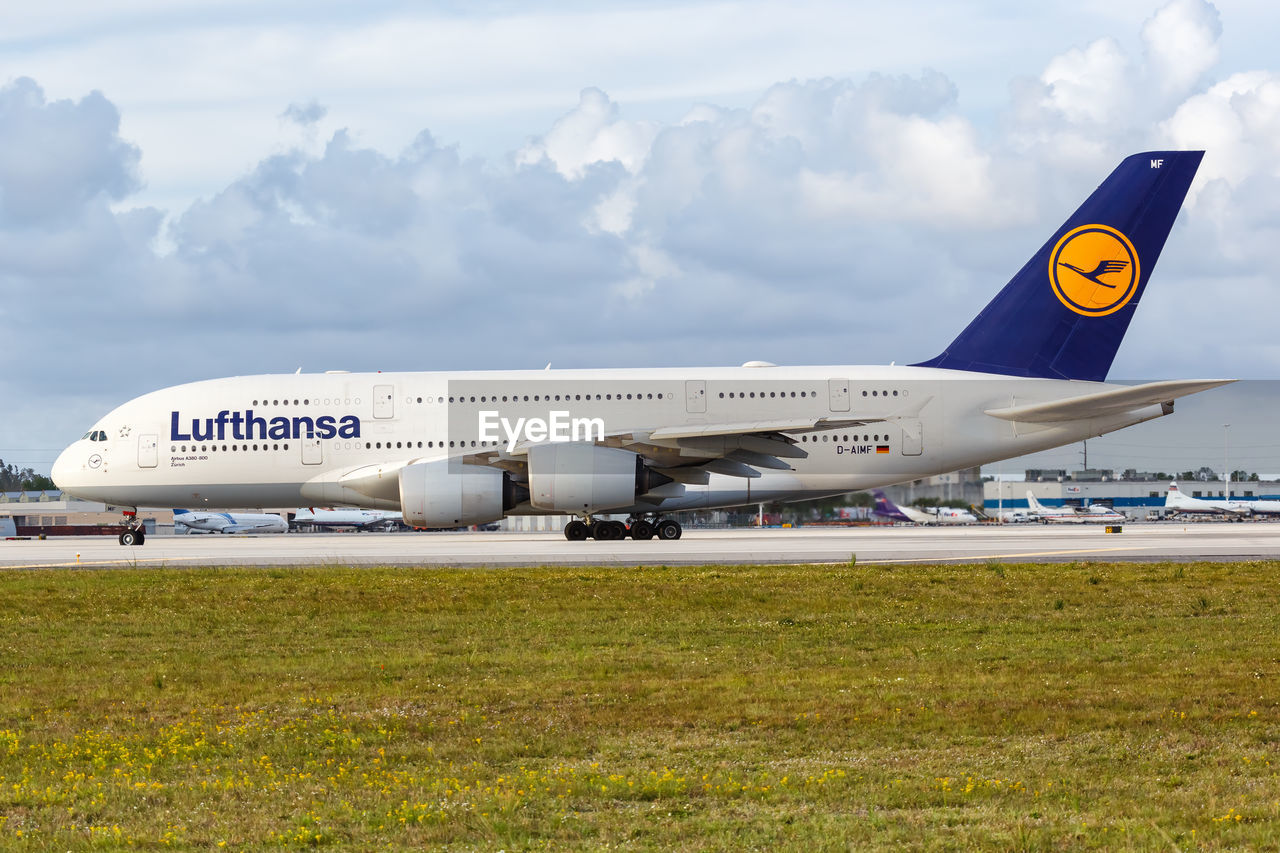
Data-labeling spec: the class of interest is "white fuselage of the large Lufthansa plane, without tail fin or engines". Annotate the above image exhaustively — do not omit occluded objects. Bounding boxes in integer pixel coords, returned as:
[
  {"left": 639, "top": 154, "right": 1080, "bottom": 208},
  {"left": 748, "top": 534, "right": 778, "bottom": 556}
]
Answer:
[{"left": 54, "top": 366, "right": 1167, "bottom": 515}]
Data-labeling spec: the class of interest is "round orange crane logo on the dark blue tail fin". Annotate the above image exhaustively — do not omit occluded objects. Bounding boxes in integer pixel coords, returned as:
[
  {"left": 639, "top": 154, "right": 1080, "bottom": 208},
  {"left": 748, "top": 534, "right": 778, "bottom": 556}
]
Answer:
[{"left": 1048, "top": 225, "right": 1142, "bottom": 316}]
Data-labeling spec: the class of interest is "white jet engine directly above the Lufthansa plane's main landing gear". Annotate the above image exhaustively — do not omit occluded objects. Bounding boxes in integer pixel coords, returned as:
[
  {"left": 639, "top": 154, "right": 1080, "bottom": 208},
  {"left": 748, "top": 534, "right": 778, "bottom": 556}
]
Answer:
[{"left": 529, "top": 442, "right": 671, "bottom": 512}]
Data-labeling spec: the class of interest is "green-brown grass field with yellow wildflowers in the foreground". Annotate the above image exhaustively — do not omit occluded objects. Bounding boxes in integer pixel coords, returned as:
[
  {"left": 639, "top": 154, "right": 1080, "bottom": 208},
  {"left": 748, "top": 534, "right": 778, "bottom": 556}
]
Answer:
[{"left": 0, "top": 562, "right": 1280, "bottom": 850}]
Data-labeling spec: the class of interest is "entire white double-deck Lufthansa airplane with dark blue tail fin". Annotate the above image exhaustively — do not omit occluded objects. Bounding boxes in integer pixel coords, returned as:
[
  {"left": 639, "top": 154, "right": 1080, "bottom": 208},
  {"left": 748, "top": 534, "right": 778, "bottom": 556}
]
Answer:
[{"left": 52, "top": 151, "right": 1231, "bottom": 546}]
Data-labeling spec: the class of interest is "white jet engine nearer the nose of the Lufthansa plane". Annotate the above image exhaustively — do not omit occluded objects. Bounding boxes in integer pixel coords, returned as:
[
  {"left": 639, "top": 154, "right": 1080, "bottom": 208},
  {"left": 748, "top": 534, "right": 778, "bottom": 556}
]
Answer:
[{"left": 399, "top": 460, "right": 517, "bottom": 528}]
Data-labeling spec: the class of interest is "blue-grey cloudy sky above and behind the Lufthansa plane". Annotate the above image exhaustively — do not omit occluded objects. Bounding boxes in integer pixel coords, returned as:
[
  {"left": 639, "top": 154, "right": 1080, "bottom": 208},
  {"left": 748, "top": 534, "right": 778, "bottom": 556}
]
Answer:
[{"left": 0, "top": 0, "right": 1280, "bottom": 471}]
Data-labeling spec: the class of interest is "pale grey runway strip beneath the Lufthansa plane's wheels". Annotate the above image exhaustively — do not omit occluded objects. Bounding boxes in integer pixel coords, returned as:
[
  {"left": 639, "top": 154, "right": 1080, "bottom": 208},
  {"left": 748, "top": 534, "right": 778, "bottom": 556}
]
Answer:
[{"left": 0, "top": 523, "right": 1280, "bottom": 569}]
